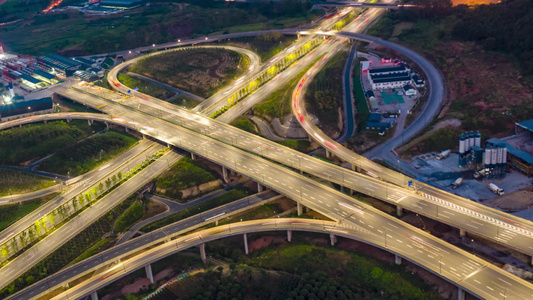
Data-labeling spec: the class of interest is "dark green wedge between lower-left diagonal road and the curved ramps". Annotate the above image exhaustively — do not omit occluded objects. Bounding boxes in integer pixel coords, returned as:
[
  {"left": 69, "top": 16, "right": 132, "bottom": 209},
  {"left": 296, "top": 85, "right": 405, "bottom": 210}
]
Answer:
[{"left": 0, "top": 196, "right": 136, "bottom": 298}]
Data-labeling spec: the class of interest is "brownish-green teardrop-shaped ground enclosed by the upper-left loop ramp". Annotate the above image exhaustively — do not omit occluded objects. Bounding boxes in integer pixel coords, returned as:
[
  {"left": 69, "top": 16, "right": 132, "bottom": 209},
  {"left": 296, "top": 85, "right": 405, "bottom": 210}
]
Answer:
[{"left": 129, "top": 48, "right": 250, "bottom": 98}]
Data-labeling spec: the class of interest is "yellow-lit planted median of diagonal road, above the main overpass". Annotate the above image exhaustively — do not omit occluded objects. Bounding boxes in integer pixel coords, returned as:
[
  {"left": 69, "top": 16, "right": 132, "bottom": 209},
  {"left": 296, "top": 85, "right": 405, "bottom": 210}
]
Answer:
[{"left": 209, "top": 38, "right": 322, "bottom": 119}]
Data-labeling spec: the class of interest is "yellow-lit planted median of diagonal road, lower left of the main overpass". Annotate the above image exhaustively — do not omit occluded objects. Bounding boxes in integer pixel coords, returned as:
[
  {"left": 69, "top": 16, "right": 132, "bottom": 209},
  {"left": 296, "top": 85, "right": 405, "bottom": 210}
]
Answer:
[{"left": 0, "top": 148, "right": 168, "bottom": 265}]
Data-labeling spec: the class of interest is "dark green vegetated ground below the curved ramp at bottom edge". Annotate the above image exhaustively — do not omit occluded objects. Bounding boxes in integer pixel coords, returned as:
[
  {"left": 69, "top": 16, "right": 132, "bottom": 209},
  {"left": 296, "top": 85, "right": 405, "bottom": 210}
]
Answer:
[{"left": 159, "top": 241, "right": 441, "bottom": 300}]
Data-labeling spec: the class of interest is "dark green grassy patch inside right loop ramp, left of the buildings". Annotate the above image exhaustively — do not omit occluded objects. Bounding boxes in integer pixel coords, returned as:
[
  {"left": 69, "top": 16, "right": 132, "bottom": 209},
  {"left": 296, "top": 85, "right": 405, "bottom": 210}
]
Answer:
[{"left": 305, "top": 49, "right": 349, "bottom": 131}]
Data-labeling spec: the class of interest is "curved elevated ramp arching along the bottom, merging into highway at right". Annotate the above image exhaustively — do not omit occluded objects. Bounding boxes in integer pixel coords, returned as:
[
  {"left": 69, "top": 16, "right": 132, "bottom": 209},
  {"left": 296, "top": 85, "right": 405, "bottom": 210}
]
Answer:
[{"left": 9, "top": 218, "right": 533, "bottom": 300}]
